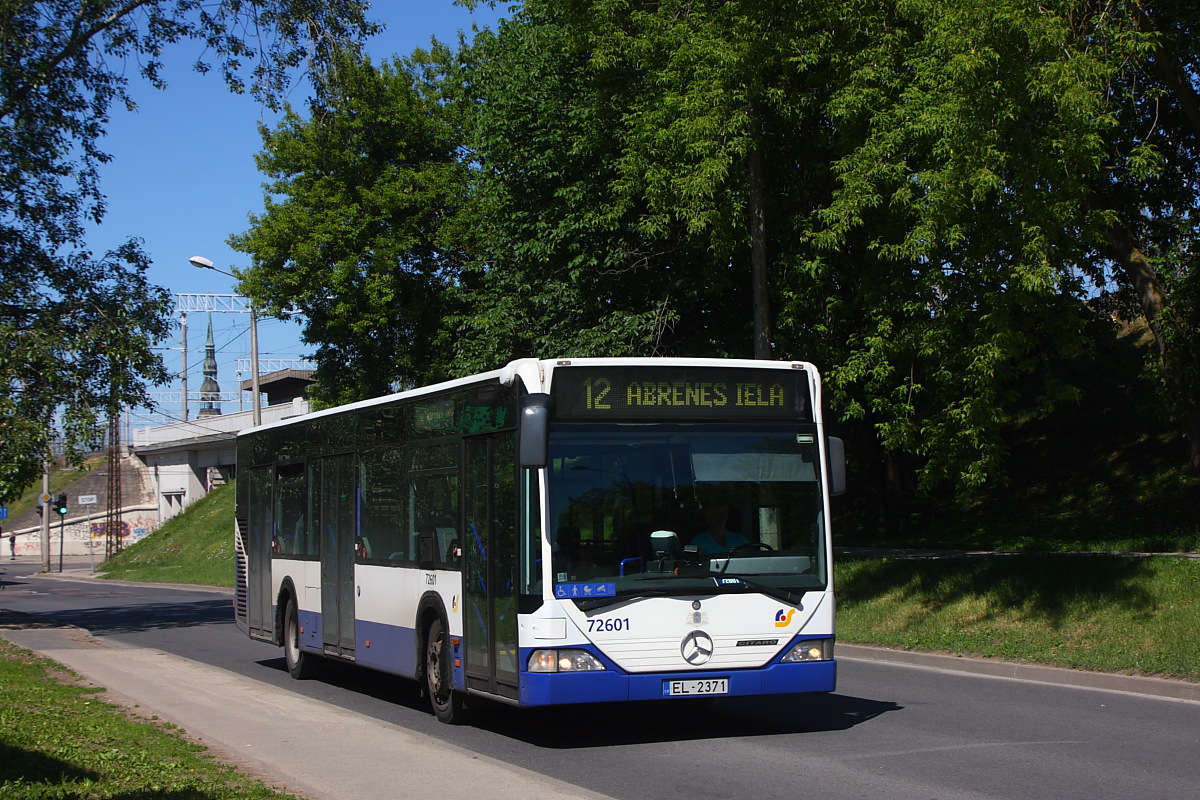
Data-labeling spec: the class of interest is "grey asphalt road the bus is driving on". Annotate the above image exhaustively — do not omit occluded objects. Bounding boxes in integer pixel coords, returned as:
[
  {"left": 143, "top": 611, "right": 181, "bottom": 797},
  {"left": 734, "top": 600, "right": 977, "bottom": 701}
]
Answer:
[{"left": 0, "top": 556, "right": 1200, "bottom": 800}]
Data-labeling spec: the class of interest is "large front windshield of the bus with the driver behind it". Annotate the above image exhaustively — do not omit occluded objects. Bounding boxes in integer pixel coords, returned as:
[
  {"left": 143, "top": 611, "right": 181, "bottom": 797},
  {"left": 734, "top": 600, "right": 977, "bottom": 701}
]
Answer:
[{"left": 546, "top": 422, "right": 827, "bottom": 600}]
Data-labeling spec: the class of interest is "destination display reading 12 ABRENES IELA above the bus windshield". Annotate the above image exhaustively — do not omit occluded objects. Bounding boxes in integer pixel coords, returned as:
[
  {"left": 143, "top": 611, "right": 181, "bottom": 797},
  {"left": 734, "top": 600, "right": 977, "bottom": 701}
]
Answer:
[{"left": 551, "top": 366, "right": 811, "bottom": 422}]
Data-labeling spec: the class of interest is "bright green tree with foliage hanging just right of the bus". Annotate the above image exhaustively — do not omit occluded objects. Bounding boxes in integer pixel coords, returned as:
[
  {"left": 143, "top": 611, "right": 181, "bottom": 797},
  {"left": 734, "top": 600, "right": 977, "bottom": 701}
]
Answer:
[{"left": 787, "top": 0, "right": 1104, "bottom": 498}]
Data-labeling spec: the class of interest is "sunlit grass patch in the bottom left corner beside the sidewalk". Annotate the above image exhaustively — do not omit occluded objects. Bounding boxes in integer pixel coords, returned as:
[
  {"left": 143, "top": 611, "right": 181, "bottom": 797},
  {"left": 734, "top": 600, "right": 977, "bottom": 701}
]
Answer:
[{"left": 0, "top": 639, "right": 293, "bottom": 800}]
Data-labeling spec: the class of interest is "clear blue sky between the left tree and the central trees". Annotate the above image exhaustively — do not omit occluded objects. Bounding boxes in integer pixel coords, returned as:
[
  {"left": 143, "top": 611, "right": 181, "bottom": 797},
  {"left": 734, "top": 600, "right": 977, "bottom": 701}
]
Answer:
[{"left": 89, "top": 0, "right": 505, "bottom": 427}]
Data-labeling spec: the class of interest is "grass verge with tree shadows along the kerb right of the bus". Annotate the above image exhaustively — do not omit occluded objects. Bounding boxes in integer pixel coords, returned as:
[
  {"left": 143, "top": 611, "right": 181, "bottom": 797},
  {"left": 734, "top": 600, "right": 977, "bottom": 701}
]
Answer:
[{"left": 836, "top": 554, "right": 1200, "bottom": 681}]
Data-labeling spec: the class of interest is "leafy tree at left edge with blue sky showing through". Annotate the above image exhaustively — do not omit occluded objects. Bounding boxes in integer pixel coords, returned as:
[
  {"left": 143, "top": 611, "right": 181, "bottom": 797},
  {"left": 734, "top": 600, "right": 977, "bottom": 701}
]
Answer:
[{"left": 0, "top": 0, "right": 376, "bottom": 498}]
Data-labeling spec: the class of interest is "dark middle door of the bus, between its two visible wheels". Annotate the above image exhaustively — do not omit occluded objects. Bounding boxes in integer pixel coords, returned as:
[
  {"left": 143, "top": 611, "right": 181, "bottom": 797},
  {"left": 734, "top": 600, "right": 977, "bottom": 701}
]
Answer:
[{"left": 320, "top": 455, "right": 358, "bottom": 658}]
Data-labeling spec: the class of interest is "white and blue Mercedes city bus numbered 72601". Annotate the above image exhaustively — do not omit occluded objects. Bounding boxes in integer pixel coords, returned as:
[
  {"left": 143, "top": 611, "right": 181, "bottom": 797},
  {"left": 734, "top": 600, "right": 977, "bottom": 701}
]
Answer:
[{"left": 234, "top": 359, "right": 845, "bottom": 722}]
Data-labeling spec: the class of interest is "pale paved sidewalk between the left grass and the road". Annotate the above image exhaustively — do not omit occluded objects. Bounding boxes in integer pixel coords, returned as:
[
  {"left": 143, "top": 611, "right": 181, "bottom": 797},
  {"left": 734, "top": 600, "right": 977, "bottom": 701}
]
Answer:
[{"left": 0, "top": 627, "right": 605, "bottom": 800}]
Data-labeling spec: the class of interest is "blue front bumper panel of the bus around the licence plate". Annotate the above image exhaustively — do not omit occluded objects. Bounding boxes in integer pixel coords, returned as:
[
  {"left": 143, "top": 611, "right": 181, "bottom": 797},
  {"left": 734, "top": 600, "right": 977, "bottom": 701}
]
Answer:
[{"left": 521, "top": 650, "right": 838, "bottom": 705}]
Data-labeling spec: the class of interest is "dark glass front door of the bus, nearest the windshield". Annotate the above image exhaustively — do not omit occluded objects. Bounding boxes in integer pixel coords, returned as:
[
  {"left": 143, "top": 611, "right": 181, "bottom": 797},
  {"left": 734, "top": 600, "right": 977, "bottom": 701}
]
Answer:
[{"left": 463, "top": 433, "right": 517, "bottom": 699}]
